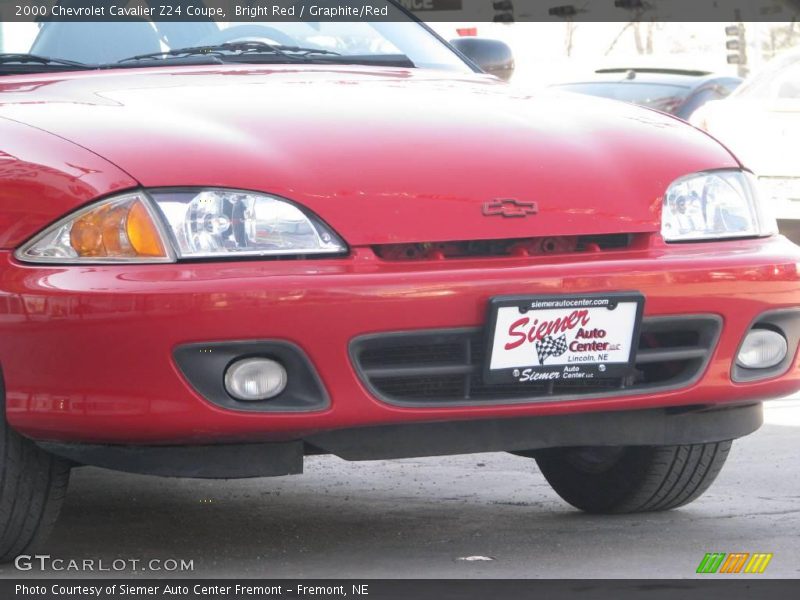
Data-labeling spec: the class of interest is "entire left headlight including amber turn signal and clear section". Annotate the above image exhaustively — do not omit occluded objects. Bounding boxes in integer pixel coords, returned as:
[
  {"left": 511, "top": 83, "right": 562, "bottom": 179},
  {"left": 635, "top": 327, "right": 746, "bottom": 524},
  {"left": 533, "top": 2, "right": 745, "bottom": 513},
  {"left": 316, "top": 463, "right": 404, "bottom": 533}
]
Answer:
[{"left": 16, "top": 189, "right": 347, "bottom": 264}]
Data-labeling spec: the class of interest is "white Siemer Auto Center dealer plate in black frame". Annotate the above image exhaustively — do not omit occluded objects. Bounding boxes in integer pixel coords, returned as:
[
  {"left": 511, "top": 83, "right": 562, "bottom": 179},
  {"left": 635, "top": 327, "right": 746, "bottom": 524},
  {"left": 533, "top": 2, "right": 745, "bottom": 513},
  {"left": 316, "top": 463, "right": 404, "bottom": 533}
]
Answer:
[{"left": 484, "top": 292, "right": 644, "bottom": 383}]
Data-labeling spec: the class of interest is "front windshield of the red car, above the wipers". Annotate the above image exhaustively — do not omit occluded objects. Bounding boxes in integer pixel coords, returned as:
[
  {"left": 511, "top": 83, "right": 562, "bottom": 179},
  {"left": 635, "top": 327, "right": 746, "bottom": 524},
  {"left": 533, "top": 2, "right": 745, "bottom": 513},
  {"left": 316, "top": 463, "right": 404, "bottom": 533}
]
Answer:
[{"left": 3, "top": 0, "right": 471, "bottom": 73}]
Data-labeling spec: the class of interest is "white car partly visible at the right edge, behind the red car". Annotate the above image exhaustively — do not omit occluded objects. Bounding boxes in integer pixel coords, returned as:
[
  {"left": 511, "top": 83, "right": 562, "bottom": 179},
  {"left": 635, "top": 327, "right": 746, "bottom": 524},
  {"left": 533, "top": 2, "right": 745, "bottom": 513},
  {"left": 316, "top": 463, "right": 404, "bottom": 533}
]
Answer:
[{"left": 691, "top": 49, "right": 800, "bottom": 237}]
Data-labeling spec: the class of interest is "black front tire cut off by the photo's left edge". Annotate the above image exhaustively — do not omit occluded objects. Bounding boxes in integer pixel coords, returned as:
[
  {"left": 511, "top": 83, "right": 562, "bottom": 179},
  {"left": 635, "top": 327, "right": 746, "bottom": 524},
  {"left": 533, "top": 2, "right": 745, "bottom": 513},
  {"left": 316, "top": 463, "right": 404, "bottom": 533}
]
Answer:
[{"left": 0, "top": 380, "right": 70, "bottom": 563}]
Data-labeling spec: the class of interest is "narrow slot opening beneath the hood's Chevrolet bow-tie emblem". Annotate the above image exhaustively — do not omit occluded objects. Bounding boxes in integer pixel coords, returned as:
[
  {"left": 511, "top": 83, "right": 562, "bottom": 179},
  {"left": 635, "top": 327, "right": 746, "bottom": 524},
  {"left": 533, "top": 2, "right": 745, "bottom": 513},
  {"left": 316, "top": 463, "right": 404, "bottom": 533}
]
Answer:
[{"left": 373, "top": 233, "right": 646, "bottom": 261}]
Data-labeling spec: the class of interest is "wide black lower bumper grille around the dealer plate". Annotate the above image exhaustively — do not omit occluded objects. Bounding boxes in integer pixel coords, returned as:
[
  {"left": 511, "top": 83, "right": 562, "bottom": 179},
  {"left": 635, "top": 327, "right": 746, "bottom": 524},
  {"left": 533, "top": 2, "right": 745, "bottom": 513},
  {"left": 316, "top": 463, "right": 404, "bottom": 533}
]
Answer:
[{"left": 350, "top": 315, "right": 722, "bottom": 406}]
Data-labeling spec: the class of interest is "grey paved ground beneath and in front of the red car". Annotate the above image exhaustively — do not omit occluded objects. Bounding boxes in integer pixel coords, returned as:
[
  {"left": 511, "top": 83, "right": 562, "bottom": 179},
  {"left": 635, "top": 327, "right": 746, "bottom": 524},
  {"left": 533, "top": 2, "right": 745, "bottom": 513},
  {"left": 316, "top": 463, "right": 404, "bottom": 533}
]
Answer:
[{"left": 0, "top": 398, "right": 800, "bottom": 578}]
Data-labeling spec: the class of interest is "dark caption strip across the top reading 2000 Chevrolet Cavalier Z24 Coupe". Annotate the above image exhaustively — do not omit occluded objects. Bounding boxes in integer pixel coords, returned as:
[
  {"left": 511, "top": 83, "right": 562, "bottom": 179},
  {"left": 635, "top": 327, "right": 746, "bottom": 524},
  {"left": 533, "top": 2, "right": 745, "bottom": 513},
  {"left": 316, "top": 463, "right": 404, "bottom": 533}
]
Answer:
[{"left": 0, "top": 0, "right": 800, "bottom": 23}]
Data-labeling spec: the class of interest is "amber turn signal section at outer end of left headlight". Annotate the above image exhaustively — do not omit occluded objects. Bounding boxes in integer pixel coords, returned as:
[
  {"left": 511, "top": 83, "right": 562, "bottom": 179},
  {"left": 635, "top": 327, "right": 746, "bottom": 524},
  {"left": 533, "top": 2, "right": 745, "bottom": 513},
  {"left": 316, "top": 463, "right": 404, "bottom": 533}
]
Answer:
[{"left": 17, "top": 193, "right": 173, "bottom": 264}]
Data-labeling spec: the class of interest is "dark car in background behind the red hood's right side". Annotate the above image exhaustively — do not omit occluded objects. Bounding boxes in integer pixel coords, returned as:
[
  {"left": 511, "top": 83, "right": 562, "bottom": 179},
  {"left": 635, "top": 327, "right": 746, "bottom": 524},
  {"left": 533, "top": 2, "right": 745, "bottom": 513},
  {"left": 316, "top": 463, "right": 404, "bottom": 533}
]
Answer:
[{"left": 555, "top": 67, "right": 742, "bottom": 119}]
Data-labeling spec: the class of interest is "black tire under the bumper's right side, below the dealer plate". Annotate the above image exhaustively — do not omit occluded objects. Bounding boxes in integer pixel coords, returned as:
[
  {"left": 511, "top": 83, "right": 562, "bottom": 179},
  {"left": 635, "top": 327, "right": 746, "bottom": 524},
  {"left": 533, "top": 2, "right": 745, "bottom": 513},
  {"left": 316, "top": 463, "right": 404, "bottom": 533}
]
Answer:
[{"left": 533, "top": 441, "right": 732, "bottom": 514}]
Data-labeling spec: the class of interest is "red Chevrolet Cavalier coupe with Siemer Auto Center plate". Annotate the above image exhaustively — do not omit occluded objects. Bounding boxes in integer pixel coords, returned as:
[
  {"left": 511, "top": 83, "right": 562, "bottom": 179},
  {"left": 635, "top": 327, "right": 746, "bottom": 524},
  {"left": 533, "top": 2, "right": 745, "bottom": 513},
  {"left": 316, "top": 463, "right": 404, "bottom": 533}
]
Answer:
[{"left": 0, "top": 11, "right": 800, "bottom": 559}]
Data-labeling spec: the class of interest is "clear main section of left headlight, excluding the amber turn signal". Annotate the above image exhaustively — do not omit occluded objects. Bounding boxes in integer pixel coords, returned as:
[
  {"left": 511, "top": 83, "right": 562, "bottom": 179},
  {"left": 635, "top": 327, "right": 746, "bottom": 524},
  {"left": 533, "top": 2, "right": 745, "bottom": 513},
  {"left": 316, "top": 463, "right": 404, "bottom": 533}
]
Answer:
[{"left": 152, "top": 190, "right": 347, "bottom": 258}]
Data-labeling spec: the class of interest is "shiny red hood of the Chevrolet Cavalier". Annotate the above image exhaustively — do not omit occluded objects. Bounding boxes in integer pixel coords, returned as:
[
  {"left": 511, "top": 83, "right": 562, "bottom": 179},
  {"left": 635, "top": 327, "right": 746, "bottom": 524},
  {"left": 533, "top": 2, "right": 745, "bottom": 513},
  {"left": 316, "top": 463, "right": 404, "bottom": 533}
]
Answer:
[{"left": 0, "top": 65, "right": 737, "bottom": 245}]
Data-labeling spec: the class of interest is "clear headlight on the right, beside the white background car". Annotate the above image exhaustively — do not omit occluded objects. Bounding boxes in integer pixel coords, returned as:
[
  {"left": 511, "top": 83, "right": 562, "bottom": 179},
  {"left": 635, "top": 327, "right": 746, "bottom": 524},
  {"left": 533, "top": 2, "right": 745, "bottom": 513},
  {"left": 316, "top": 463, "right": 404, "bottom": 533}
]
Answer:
[{"left": 661, "top": 170, "right": 778, "bottom": 242}]
